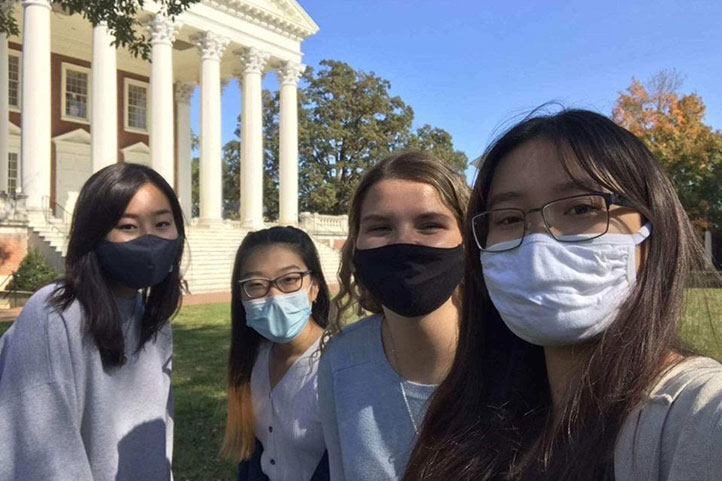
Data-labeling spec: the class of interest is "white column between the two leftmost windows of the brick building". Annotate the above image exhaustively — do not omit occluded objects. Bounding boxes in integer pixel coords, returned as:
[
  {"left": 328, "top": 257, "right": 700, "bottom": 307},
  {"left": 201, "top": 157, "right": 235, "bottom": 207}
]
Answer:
[{"left": 20, "top": 0, "right": 51, "bottom": 209}]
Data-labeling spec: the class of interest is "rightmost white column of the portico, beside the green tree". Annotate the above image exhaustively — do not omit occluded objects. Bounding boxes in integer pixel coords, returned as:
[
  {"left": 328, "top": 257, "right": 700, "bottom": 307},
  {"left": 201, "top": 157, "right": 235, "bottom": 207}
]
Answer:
[{"left": 278, "top": 62, "right": 306, "bottom": 225}]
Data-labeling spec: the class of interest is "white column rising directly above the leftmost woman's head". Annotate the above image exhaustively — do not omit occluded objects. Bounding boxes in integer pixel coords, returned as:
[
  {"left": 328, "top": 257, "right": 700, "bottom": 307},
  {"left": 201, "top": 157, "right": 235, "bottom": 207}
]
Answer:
[{"left": 90, "top": 22, "right": 118, "bottom": 172}]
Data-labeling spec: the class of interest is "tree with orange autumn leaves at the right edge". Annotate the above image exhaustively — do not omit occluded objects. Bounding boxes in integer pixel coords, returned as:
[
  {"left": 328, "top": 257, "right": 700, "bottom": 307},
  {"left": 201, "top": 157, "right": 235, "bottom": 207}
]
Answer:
[{"left": 613, "top": 70, "right": 722, "bottom": 229}]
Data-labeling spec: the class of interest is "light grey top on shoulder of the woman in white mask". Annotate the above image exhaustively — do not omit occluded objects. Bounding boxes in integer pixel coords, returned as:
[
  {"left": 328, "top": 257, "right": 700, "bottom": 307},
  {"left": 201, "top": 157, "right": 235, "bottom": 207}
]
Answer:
[{"left": 614, "top": 357, "right": 722, "bottom": 481}]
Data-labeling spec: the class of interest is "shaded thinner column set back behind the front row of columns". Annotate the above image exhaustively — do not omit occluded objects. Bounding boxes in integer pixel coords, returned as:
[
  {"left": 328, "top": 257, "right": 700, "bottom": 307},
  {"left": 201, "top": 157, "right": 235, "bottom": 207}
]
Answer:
[{"left": 175, "top": 83, "right": 195, "bottom": 220}]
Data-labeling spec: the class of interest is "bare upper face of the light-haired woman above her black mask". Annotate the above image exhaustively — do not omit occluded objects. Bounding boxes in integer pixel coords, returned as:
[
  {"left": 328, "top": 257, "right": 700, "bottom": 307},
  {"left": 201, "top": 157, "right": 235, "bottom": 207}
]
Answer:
[{"left": 356, "top": 179, "right": 462, "bottom": 249}]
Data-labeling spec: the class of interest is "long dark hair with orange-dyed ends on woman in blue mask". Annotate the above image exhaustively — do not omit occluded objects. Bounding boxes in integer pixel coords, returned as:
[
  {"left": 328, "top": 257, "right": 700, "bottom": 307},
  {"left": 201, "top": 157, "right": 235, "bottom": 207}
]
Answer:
[{"left": 221, "top": 226, "right": 329, "bottom": 460}]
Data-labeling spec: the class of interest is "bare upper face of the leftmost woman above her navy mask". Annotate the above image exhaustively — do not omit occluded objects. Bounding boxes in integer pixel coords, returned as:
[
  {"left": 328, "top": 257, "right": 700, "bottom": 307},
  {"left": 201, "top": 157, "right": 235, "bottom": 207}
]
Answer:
[{"left": 105, "top": 183, "right": 178, "bottom": 242}]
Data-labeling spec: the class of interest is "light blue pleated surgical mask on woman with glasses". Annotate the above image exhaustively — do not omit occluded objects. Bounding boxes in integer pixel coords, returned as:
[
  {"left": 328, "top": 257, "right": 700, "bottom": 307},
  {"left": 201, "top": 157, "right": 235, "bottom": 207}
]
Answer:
[{"left": 243, "top": 289, "right": 311, "bottom": 344}]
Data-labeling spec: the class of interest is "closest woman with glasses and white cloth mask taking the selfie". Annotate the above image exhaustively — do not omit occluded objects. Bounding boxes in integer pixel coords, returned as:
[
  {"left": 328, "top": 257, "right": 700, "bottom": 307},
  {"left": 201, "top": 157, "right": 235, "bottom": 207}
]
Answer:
[{"left": 404, "top": 110, "right": 722, "bottom": 481}]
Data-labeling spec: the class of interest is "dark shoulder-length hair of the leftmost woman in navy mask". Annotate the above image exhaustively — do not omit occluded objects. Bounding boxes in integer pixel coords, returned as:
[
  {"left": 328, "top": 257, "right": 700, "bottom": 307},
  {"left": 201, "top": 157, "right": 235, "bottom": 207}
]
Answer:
[{"left": 50, "top": 163, "right": 185, "bottom": 366}]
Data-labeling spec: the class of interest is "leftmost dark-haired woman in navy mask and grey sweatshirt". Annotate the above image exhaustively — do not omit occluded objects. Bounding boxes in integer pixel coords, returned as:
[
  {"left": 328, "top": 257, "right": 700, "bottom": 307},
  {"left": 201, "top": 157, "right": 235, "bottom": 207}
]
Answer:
[{"left": 0, "top": 164, "right": 185, "bottom": 481}]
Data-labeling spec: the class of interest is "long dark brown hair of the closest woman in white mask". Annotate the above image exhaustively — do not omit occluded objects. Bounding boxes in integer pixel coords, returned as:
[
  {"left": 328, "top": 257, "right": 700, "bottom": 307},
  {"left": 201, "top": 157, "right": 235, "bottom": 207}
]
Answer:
[{"left": 404, "top": 110, "right": 709, "bottom": 481}]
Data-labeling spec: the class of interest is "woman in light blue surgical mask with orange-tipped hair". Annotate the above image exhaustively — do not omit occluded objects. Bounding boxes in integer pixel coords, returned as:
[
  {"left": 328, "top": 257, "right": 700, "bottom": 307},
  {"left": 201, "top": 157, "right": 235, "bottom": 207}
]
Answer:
[{"left": 222, "top": 227, "right": 329, "bottom": 481}]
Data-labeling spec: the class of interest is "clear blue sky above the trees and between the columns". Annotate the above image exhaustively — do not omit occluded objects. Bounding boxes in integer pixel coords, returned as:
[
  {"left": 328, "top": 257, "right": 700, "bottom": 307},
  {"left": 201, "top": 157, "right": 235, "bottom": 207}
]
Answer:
[{"left": 194, "top": 0, "right": 722, "bottom": 180}]
